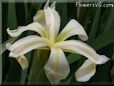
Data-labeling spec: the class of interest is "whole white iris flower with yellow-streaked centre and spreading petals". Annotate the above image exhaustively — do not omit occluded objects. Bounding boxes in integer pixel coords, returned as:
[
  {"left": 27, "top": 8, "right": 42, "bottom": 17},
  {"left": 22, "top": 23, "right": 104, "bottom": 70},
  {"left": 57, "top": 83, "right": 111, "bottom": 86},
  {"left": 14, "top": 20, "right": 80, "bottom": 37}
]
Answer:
[{"left": 6, "top": 1, "right": 109, "bottom": 84}]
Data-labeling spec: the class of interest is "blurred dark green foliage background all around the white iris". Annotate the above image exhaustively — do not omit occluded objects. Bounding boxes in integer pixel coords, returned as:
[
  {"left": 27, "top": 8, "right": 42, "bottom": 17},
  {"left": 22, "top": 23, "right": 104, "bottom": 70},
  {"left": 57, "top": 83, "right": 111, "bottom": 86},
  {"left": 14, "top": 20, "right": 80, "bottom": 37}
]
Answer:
[{"left": 0, "top": 0, "right": 114, "bottom": 85}]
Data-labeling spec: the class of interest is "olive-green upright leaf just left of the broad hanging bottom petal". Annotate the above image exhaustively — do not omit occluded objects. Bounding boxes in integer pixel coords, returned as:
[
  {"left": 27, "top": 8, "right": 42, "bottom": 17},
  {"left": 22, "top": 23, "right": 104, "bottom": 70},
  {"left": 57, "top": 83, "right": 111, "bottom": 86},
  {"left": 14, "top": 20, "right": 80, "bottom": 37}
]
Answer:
[{"left": 28, "top": 50, "right": 49, "bottom": 84}]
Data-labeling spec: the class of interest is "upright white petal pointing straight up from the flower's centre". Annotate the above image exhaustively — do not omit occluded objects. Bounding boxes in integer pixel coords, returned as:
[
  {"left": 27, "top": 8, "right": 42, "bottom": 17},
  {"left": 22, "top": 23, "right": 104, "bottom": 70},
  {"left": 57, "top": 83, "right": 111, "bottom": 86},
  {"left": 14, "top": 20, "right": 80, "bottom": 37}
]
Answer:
[{"left": 44, "top": 7, "right": 60, "bottom": 41}]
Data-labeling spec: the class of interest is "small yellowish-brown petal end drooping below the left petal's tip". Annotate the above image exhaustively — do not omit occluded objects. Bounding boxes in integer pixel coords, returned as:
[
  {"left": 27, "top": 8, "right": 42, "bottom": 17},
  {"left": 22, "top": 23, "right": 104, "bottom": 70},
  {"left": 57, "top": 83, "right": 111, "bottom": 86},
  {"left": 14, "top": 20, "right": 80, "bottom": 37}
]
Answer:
[{"left": 16, "top": 55, "right": 28, "bottom": 70}]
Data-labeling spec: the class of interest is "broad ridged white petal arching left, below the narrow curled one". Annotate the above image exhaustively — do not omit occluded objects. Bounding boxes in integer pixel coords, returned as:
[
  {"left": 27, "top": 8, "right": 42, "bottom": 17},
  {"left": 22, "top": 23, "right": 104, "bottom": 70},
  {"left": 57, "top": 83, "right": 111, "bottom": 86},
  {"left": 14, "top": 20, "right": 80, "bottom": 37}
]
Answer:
[{"left": 6, "top": 35, "right": 48, "bottom": 57}]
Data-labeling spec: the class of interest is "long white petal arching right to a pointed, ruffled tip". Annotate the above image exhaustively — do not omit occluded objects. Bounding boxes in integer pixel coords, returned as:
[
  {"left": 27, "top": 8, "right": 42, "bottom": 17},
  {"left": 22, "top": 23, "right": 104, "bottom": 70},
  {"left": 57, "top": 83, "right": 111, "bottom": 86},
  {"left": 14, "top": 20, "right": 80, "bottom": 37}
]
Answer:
[{"left": 54, "top": 40, "right": 109, "bottom": 64}]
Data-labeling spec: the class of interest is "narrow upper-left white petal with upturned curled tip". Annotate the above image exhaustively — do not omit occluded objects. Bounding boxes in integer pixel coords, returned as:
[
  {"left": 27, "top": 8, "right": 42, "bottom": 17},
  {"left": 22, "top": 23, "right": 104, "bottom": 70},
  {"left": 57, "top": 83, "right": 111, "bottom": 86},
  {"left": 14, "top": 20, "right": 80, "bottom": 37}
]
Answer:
[{"left": 7, "top": 22, "right": 44, "bottom": 37}]
